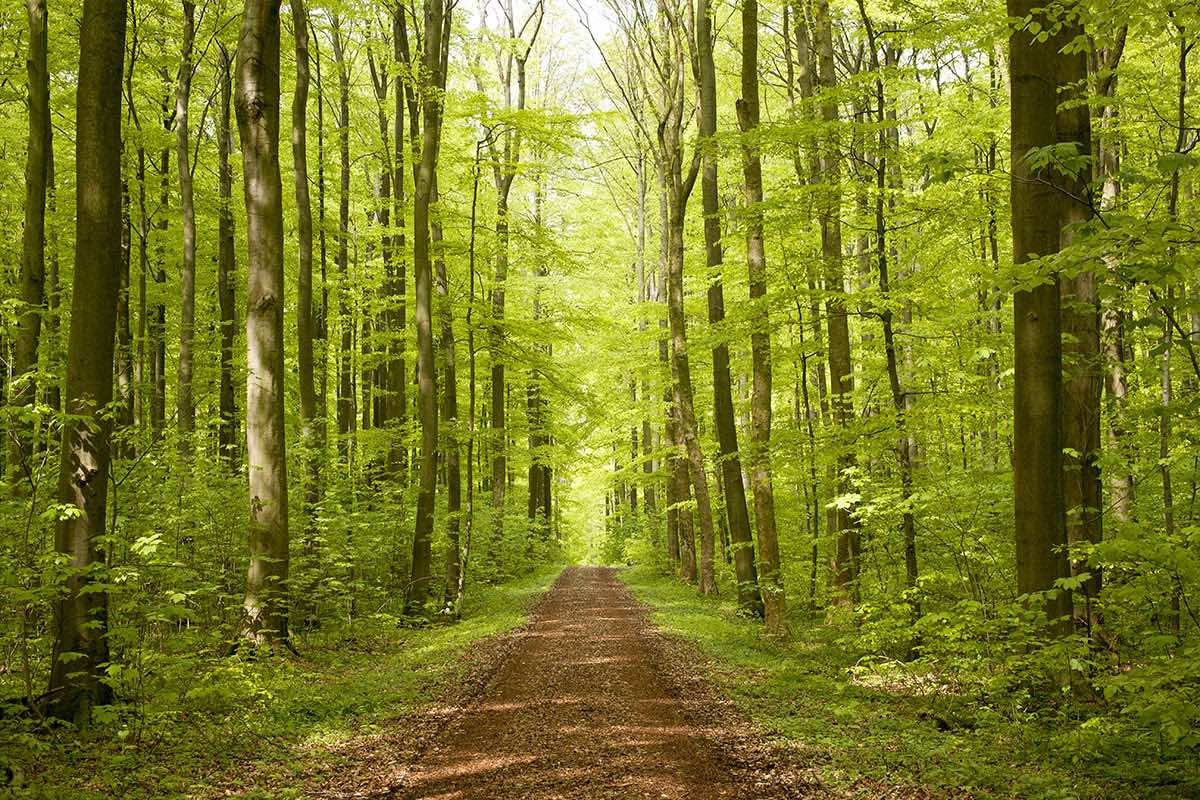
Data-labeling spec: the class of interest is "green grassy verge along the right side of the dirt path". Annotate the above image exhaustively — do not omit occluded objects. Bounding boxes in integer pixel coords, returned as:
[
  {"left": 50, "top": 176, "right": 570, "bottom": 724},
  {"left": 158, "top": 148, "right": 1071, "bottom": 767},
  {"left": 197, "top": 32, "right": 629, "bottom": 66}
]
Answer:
[{"left": 622, "top": 566, "right": 1200, "bottom": 800}]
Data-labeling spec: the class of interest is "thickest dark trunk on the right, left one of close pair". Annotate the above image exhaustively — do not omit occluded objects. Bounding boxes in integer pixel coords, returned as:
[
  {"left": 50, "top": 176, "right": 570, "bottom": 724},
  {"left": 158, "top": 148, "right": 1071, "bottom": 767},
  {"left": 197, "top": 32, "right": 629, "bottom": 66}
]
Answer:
[{"left": 1008, "top": 0, "right": 1070, "bottom": 632}]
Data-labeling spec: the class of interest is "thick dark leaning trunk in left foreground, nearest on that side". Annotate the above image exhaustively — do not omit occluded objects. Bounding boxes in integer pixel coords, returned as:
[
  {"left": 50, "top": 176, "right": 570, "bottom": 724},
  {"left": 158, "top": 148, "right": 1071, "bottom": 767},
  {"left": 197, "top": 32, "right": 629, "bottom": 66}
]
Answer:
[{"left": 49, "top": 0, "right": 126, "bottom": 724}]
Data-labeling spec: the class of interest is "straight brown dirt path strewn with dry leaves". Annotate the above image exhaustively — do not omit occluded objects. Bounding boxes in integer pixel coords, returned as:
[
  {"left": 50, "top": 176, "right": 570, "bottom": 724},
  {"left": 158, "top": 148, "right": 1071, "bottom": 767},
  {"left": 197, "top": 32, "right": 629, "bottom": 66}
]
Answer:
[{"left": 392, "top": 567, "right": 748, "bottom": 800}]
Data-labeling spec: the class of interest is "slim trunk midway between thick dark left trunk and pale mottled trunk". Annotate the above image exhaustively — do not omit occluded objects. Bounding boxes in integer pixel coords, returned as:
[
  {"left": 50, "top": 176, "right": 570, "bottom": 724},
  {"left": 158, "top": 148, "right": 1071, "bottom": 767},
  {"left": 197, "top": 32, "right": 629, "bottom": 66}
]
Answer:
[{"left": 175, "top": 0, "right": 196, "bottom": 457}]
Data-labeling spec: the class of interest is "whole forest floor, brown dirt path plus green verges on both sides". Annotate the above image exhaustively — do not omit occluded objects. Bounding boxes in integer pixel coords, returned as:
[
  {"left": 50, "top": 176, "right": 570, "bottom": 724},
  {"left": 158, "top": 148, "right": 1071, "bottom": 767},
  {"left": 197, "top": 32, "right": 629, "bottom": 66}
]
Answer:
[{"left": 14, "top": 567, "right": 1200, "bottom": 800}]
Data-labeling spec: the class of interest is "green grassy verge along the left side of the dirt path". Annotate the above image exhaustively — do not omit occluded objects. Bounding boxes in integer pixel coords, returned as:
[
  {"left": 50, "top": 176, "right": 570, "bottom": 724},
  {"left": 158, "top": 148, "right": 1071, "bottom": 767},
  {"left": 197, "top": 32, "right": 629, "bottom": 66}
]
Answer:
[{"left": 0, "top": 565, "right": 562, "bottom": 800}]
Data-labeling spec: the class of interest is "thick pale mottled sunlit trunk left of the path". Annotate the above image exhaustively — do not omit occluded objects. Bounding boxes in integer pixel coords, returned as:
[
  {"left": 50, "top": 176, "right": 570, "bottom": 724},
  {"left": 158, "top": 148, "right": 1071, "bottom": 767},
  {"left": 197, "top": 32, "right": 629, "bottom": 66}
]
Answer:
[{"left": 235, "top": 0, "right": 288, "bottom": 644}]
